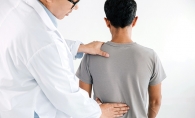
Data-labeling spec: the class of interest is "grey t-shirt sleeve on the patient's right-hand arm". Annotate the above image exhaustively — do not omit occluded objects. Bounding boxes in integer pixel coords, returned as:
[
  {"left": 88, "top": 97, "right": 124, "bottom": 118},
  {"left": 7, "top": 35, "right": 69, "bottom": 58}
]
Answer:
[{"left": 149, "top": 52, "right": 166, "bottom": 86}]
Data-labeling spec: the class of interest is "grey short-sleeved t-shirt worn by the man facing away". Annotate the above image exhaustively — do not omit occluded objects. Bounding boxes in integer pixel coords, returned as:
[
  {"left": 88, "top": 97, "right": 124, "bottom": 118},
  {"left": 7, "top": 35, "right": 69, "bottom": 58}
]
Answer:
[{"left": 76, "top": 42, "right": 166, "bottom": 118}]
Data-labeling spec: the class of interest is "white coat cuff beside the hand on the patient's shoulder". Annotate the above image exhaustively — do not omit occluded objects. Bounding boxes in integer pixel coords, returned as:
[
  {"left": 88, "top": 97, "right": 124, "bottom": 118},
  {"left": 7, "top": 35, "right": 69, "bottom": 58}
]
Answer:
[{"left": 65, "top": 39, "right": 83, "bottom": 59}]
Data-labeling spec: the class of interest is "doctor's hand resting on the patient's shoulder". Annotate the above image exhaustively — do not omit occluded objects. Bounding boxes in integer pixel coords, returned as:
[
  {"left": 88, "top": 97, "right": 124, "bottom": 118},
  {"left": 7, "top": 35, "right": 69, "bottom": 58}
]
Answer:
[{"left": 78, "top": 41, "right": 109, "bottom": 57}]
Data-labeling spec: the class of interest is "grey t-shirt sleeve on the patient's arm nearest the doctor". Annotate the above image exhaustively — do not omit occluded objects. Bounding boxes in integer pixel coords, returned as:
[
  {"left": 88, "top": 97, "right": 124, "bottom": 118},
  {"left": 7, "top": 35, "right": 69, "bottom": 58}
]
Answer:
[{"left": 76, "top": 54, "right": 93, "bottom": 84}]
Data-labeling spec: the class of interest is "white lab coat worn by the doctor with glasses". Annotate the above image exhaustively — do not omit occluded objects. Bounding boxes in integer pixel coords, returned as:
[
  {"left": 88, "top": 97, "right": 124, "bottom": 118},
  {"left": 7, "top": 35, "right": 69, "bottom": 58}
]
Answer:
[{"left": 0, "top": 0, "right": 101, "bottom": 118}]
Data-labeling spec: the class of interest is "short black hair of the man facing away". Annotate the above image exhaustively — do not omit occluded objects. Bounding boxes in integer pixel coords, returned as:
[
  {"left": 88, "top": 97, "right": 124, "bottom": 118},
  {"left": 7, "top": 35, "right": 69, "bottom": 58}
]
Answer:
[{"left": 104, "top": 0, "right": 137, "bottom": 28}]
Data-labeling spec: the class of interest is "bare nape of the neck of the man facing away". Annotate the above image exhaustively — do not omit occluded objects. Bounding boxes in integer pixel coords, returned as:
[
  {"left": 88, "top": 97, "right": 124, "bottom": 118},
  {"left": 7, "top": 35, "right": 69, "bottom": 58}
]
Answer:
[{"left": 111, "top": 27, "right": 133, "bottom": 43}]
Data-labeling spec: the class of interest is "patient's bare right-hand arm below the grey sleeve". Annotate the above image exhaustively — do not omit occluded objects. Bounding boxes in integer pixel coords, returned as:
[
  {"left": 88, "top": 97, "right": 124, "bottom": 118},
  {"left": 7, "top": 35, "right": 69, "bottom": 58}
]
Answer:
[{"left": 148, "top": 84, "right": 161, "bottom": 118}]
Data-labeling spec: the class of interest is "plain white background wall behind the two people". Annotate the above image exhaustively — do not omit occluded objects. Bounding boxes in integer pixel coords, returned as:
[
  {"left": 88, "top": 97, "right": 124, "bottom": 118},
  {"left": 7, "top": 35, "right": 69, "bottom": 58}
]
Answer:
[{"left": 58, "top": 0, "right": 195, "bottom": 118}]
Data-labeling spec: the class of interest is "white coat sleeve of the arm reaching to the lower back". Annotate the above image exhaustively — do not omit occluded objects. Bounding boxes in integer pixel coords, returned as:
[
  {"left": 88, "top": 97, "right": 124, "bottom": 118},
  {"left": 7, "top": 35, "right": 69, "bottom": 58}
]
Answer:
[{"left": 27, "top": 43, "right": 101, "bottom": 118}]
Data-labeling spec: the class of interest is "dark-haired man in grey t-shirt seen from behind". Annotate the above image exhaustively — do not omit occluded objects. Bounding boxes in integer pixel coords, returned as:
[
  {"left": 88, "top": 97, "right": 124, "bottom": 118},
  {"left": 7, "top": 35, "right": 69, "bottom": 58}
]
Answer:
[{"left": 76, "top": 0, "right": 166, "bottom": 118}]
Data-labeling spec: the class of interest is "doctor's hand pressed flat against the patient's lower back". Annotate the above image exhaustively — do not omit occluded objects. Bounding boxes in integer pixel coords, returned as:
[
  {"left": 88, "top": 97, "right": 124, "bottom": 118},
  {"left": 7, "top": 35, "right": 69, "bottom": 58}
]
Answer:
[{"left": 96, "top": 98, "right": 129, "bottom": 118}]
